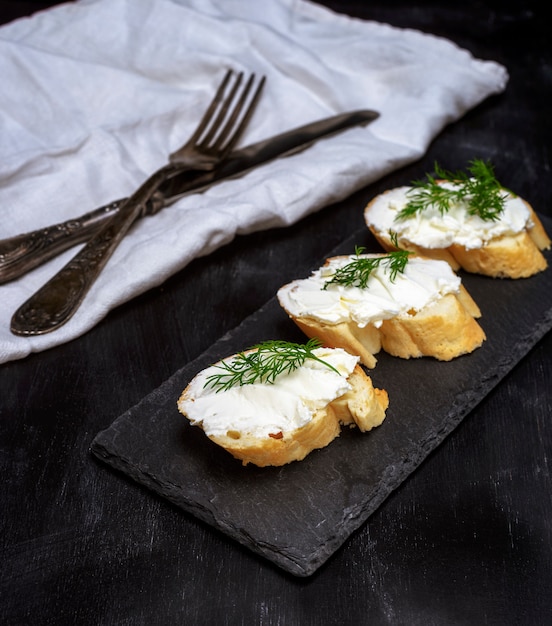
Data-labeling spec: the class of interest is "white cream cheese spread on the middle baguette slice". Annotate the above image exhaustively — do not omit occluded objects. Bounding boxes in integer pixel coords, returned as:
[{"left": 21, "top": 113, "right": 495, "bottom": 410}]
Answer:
[{"left": 278, "top": 254, "right": 461, "bottom": 328}]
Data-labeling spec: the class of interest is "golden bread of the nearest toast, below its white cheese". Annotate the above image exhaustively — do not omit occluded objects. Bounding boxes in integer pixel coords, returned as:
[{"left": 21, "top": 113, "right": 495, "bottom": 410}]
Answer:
[{"left": 177, "top": 365, "right": 389, "bottom": 467}]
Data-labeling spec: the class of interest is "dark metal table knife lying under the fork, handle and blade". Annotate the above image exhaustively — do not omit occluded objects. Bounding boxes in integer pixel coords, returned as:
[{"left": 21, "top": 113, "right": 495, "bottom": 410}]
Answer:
[{"left": 0, "top": 109, "right": 379, "bottom": 284}]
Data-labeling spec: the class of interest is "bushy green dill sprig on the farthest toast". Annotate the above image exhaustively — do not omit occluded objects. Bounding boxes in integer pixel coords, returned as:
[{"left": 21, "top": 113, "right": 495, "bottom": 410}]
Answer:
[{"left": 395, "top": 159, "right": 508, "bottom": 220}]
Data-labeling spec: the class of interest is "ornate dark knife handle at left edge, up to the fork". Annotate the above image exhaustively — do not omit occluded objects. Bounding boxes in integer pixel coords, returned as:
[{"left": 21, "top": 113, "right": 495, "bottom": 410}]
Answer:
[{"left": 0, "top": 200, "right": 123, "bottom": 285}]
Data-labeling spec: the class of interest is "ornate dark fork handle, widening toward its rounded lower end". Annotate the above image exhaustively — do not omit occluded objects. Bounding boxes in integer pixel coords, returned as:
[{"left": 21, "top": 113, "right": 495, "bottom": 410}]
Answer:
[{"left": 11, "top": 170, "right": 166, "bottom": 336}]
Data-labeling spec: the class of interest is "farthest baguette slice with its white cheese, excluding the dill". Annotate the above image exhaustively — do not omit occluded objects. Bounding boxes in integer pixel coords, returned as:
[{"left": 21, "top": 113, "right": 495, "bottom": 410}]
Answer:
[{"left": 364, "top": 181, "right": 551, "bottom": 279}]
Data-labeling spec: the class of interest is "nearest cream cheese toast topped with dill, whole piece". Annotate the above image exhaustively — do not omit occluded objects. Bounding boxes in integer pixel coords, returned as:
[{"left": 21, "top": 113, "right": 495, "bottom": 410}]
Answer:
[{"left": 178, "top": 340, "right": 388, "bottom": 467}]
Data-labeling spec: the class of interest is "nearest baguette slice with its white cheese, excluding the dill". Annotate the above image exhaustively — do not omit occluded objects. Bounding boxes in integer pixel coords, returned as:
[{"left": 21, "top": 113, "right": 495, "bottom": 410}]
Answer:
[{"left": 177, "top": 348, "right": 389, "bottom": 467}]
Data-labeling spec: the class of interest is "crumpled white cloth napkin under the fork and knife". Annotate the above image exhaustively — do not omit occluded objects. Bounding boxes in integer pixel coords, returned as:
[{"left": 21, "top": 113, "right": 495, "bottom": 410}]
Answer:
[{"left": 0, "top": 0, "right": 508, "bottom": 363}]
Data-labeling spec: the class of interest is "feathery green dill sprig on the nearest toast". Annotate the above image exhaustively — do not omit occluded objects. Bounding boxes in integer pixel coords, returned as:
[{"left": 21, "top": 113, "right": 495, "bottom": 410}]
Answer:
[{"left": 205, "top": 338, "right": 339, "bottom": 393}]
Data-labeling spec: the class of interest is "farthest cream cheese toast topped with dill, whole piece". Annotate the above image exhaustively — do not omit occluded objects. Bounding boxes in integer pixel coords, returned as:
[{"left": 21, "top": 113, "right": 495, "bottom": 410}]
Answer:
[{"left": 364, "top": 159, "right": 550, "bottom": 278}]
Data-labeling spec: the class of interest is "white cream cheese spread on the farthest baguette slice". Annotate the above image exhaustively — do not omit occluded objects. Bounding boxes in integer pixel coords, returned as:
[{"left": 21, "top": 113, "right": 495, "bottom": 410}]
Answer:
[{"left": 366, "top": 183, "right": 532, "bottom": 250}]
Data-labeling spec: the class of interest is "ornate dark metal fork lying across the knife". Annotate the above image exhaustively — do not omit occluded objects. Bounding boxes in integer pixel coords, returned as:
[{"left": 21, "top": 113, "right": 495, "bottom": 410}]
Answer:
[{"left": 10, "top": 70, "right": 265, "bottom": 336}]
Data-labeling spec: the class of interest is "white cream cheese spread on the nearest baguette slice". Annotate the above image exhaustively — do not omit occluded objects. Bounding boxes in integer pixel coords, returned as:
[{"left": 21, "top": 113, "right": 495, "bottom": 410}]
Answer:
[{"left": 179, "top": 348, "right": 359, "bottom": 437}]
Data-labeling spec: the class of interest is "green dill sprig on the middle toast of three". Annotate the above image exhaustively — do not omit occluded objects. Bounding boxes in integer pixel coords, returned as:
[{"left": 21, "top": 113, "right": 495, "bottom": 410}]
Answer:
[{"left": 322, "top": 240, "right": 412, "bottom": 289}]
